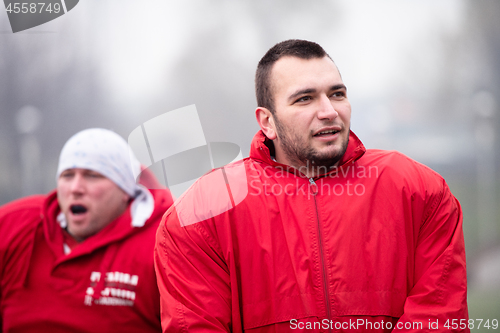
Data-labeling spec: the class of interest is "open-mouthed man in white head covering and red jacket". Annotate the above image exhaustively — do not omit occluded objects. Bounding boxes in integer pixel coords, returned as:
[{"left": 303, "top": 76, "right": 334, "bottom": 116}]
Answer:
[{"left": 0, "top": 128, "right": 172, "bottom": 333}]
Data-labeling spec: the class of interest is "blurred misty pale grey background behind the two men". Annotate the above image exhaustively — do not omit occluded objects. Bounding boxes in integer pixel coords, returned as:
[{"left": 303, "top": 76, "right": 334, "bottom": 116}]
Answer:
[{"left": 0, "top": 0, "right": 500, "bottom": 319}]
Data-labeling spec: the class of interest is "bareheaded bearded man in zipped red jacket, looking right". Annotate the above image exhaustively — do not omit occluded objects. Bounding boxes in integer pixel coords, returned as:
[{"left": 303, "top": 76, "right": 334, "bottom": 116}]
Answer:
[{"left": 155, "top": 40, "right": 469, "bottom": 332}]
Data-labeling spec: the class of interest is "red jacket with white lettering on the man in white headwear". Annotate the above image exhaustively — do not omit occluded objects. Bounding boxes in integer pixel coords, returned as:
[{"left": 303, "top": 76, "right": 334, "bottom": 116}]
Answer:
[{"left": 0, "top": 190, "right": 172, "bottom": 333}]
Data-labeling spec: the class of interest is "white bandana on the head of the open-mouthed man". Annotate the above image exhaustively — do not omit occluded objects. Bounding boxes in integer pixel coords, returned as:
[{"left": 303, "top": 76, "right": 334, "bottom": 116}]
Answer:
[{"left": 56, "top": 128, "right": 154, "bottom": 227}]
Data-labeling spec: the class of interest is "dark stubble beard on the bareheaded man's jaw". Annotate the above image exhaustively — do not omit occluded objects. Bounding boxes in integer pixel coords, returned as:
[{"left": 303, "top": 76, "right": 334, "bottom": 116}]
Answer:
[{"left": 274, "top": 115, "right": 349, "bottom": 175}]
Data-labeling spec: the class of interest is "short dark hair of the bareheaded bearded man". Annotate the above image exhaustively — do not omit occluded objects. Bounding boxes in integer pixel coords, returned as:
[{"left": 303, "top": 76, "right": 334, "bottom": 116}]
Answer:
[{"left": 255, "top": 39, "right": 331, "bottom": 114}]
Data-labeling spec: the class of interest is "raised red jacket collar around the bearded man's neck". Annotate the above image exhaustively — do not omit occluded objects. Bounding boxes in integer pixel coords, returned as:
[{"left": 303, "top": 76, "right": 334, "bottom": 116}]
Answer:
[{"left": 250, "top": 131, "right": 366, "bottom": 178}]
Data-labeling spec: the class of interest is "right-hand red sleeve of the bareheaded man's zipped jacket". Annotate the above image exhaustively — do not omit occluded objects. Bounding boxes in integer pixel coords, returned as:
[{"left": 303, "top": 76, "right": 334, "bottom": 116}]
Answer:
[{"left": 394, "top": 180, "right": 470, "bottom": 332}]
